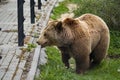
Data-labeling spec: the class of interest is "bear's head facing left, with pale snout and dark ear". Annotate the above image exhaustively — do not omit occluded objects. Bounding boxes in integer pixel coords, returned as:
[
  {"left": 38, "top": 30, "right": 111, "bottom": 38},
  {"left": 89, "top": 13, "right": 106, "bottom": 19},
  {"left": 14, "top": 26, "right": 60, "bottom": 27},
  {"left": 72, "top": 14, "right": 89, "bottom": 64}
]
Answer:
[{"left": 37, "top": 18, "right": 77, "bottom": 47}]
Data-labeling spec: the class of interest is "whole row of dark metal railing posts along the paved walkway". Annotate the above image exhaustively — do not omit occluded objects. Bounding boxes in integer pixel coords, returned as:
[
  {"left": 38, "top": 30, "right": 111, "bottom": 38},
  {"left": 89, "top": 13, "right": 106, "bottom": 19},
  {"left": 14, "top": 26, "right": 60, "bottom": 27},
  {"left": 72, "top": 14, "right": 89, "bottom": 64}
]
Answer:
[{"left": 17, "top": 0, "right": 47, "bottom": 46}]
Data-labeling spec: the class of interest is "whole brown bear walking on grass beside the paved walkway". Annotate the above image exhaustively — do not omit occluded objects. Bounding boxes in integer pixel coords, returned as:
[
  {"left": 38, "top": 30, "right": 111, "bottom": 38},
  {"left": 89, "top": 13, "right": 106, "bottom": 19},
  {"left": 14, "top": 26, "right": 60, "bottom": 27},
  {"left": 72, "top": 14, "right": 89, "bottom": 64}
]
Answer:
[{"left": 37, "top": 13, "right": 110, "bottom": 74}]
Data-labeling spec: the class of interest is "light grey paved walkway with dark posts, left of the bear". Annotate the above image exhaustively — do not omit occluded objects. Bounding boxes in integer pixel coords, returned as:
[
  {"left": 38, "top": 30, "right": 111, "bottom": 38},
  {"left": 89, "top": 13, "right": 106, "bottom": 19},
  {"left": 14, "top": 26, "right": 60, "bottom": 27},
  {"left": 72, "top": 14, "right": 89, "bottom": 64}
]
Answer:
[{"left": 0, "top": 0, "right": 57, "bottom": 80}]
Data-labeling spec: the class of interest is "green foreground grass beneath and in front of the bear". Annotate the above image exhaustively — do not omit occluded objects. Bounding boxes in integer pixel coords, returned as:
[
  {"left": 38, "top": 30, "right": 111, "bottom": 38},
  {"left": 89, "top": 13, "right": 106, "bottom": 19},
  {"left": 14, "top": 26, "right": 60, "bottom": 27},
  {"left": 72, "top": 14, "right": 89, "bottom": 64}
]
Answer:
[{"left": 36, "top": 47, "right": 120, "bottom": 80}]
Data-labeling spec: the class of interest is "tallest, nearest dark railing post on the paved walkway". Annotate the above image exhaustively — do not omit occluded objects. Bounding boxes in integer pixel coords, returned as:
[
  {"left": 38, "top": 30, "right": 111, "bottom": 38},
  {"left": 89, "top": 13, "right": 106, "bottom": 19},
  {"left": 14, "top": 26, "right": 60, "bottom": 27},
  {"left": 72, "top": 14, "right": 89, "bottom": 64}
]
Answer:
[{"left": 17, "top": 0, "right": 25, "bottom": 46}]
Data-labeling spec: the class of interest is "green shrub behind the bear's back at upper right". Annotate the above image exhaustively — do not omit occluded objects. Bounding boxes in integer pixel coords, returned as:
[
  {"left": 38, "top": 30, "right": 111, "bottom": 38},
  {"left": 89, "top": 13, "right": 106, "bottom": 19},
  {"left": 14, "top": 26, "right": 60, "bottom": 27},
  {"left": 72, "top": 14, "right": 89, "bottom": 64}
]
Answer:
[{"left": 69, "top": 0, "right": 120, "bottom": 30}]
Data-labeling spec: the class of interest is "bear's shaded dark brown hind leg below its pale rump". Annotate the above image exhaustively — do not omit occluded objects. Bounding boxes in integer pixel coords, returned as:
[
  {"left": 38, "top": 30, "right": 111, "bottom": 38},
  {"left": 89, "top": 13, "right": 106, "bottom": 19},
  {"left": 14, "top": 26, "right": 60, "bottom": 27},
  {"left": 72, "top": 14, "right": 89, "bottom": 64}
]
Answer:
[{"left": 91, "top": 37, "right": 109, "bottom": 66}]
